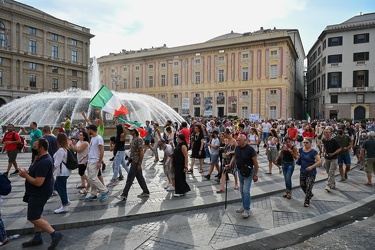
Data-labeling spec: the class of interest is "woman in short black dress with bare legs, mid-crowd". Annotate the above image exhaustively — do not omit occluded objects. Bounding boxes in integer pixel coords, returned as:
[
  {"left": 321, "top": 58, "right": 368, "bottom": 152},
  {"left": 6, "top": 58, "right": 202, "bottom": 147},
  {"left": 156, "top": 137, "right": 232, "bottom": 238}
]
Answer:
[{"left": 188, "top": 124, "right": 206, "bottom": 173}]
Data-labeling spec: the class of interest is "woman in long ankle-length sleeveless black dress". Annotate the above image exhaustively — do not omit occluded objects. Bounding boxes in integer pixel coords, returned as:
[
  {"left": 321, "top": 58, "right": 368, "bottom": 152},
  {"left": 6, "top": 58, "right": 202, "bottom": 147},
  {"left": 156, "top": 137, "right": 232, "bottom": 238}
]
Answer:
[{"left": 172, "top": 134, "right": 190, "bottom": 197}]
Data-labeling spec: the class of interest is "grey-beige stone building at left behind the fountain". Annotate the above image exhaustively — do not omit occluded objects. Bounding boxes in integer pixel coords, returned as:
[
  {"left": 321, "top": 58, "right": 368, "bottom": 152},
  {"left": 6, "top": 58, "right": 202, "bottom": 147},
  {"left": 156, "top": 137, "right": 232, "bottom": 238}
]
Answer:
[{"left": 0, "top": 1, "right": 93, "bottom": 106}]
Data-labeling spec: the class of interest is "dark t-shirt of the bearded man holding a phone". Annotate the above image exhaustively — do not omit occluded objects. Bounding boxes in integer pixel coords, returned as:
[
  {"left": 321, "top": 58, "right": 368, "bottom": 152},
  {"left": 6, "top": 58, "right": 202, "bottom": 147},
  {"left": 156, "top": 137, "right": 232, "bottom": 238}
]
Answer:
[{"left": 25, "top": 154, "right": 53, "bottom": 197}]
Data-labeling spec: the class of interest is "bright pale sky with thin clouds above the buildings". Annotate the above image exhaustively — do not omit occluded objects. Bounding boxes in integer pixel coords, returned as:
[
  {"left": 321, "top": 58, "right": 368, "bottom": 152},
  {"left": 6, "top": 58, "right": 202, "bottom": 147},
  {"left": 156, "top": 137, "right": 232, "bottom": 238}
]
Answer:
[{"left": 18, "top": 0, "right": 375, "bottom": 58}]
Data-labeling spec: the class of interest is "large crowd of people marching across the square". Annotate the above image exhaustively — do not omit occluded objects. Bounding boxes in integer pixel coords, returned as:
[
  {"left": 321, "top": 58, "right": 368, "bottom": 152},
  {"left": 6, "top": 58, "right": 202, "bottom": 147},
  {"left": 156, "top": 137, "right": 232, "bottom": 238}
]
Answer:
[{"left": 0, "top": 114, "right": 375, "bottom": 249}]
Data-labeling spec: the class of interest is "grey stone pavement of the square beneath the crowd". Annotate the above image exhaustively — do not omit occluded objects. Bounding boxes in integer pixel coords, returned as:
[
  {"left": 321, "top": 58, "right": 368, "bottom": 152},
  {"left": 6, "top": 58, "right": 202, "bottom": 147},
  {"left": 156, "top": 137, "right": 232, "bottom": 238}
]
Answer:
[{"left": 0, "top": 146, "right": 375, "bottom": 249}]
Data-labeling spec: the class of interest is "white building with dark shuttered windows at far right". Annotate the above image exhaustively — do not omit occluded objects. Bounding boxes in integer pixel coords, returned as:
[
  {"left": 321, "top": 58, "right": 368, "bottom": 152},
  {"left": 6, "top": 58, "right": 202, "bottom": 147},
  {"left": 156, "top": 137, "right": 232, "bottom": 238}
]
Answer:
[{"left": 307, "top": 13, "right": 375, "bottom": 120}]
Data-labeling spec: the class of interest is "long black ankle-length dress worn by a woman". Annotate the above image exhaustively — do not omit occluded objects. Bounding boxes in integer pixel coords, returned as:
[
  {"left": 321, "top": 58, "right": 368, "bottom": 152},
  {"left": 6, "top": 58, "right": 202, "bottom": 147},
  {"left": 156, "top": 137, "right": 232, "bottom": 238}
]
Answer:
[{"left": 173, "top": 142, "right": 190, "bottom": 194}]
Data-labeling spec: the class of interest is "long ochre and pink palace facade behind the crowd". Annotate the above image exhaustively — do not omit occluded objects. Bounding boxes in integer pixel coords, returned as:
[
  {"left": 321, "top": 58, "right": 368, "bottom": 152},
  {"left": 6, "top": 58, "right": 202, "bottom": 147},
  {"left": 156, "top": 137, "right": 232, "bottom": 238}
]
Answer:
[{"left": 98, "top": 28, "right": 305, "bottom": 119}]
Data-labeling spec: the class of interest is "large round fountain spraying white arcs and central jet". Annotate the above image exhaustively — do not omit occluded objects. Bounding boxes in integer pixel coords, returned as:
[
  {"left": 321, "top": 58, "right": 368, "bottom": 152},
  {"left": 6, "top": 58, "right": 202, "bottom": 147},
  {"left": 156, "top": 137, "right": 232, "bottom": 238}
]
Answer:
[{"left": 0, "top": 58, "right": 184, "bottom": 131}]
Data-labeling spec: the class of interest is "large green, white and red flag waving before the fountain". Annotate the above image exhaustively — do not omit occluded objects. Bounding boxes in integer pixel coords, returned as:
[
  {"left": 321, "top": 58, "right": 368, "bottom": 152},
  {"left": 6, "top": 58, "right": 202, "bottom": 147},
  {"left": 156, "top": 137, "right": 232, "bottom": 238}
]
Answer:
[{"left": 90, "top": 85, "right": 129, "bottom": 116}]
